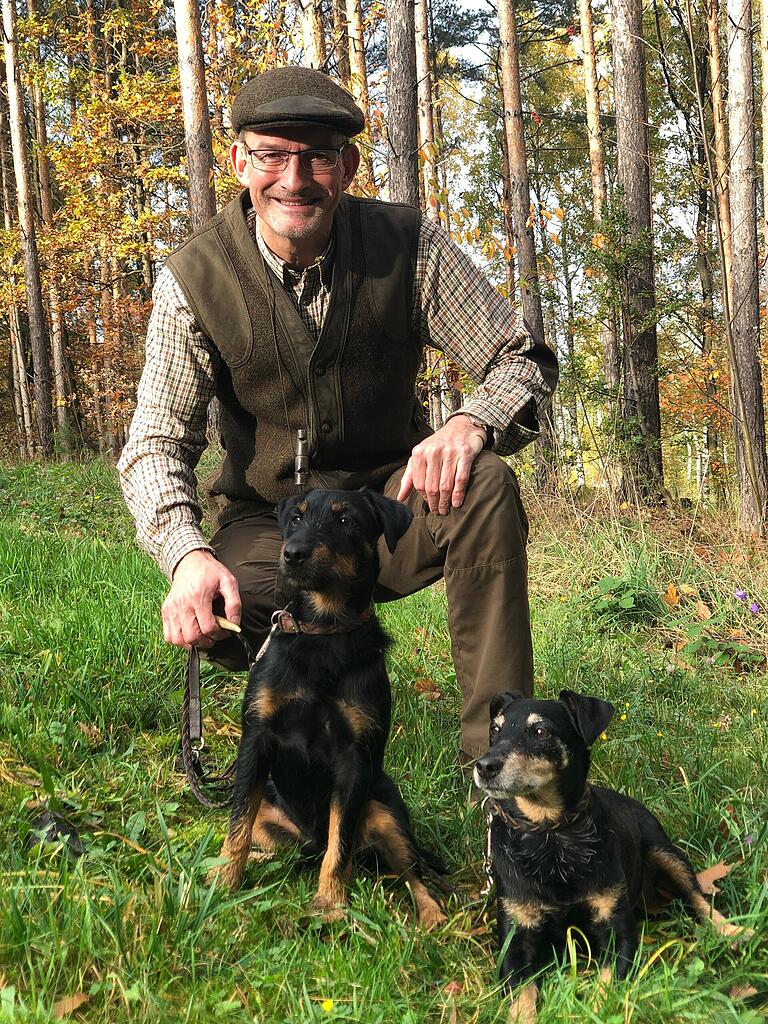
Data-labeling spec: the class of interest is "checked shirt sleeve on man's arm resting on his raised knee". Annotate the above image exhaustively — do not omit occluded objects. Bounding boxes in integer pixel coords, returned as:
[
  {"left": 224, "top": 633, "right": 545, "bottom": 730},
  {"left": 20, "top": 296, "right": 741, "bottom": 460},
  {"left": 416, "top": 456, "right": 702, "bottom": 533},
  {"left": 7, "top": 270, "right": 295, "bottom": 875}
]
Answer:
[{"left": 414, "top": 217, "right": 558, "bottom": 455}]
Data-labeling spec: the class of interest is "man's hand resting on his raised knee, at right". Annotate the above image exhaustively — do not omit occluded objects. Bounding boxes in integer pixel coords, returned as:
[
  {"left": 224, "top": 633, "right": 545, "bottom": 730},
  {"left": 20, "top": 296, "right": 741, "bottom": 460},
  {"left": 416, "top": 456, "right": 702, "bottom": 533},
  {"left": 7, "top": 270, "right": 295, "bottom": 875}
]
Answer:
[{"left": 397, "top": 416, "right": 485, "bottom": 515}]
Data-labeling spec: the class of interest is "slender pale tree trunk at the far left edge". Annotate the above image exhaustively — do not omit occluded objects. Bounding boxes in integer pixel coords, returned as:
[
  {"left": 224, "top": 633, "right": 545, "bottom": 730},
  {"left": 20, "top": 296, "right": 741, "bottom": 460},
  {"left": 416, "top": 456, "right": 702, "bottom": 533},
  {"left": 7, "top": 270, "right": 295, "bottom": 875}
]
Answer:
[{"left": 2, "top": 0, "right": 53, "bottom": 458}]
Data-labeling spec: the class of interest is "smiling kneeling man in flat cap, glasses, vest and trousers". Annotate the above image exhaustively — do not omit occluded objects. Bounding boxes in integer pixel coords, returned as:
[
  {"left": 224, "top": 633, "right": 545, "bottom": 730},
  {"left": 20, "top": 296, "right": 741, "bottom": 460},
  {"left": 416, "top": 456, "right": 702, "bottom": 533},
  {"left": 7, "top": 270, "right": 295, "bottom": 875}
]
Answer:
[{"left": 119, "top": 68, "right": 557, "bottom": 760}]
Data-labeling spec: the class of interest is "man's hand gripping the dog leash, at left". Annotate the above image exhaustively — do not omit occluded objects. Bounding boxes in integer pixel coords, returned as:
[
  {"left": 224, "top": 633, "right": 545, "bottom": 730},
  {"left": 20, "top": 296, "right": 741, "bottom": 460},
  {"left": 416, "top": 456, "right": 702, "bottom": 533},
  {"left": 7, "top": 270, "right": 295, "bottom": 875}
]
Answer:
[{"left": 162, "top": 550, "right": 241, "bottom": 650}]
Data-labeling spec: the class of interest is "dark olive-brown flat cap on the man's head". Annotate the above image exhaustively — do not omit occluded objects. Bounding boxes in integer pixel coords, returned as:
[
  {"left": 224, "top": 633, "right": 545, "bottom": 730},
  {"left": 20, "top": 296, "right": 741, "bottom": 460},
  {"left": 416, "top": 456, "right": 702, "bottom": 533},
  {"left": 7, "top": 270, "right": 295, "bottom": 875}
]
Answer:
[{"left": 232, "top": 68, "right": 366, "bottom": 138}]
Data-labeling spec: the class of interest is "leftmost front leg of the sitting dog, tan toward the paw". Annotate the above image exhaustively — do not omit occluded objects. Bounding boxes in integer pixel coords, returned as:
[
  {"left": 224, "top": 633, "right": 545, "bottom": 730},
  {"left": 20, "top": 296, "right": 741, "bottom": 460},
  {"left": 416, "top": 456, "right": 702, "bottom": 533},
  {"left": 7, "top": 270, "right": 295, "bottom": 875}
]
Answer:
[{"left": 208, "top": 722, "right": 268, "bottom": 889}]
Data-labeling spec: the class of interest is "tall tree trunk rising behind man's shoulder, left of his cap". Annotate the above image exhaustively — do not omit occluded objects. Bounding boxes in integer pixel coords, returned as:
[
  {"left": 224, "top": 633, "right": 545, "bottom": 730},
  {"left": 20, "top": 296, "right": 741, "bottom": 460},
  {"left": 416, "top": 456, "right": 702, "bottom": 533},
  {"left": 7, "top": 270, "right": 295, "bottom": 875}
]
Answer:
[{"left": 173, "top": 0, "right": 216, "bottom": 230}]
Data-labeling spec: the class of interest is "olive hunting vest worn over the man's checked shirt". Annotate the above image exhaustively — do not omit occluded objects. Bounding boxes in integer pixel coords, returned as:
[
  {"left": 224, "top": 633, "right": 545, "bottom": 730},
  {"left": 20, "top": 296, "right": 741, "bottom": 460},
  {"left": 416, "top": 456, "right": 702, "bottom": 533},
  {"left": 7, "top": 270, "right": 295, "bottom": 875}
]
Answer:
[{"left": 168, "top": 191, "right": 430, "bottom": 525}]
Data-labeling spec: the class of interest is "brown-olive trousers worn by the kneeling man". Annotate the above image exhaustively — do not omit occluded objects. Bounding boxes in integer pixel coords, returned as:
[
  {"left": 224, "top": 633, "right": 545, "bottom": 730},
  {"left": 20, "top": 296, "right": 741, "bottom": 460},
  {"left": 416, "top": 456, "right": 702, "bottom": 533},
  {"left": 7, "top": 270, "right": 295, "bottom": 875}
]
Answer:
[{"left": 208, "top": 452, "right": 534, "bottom": 757}]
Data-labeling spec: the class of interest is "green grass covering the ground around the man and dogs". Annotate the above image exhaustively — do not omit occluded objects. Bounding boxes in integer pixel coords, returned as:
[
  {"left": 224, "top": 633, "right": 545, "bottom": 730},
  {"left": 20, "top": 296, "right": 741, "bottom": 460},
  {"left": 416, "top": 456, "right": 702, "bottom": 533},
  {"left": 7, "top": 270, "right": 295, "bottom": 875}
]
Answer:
[{"left": 0, "top": 462, "right": 768, "bottom": 1024}]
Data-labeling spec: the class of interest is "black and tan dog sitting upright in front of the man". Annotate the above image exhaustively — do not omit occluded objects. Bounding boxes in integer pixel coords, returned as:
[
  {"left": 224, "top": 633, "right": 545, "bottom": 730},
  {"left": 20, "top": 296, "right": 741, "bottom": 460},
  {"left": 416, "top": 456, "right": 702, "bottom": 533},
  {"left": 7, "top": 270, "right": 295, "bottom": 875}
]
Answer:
[{"left": 212, "top": 489, "right": 444, "bottom": 928}]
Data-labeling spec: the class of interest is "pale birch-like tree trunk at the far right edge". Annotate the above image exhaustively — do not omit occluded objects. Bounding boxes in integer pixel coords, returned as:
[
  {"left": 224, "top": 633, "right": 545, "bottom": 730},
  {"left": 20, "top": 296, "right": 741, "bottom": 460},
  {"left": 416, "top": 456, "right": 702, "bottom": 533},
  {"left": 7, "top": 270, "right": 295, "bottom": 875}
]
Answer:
[{"left": 728, "top": 0, "right": 768, "bottom": 536}]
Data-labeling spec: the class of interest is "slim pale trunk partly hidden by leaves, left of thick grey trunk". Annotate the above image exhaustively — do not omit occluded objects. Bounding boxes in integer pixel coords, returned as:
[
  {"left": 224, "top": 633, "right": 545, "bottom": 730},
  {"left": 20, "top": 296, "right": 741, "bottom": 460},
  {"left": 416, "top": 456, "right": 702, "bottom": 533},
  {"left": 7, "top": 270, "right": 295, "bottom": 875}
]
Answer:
[{"left": 579, "top": 0, "right": 622, "bottom": 414}]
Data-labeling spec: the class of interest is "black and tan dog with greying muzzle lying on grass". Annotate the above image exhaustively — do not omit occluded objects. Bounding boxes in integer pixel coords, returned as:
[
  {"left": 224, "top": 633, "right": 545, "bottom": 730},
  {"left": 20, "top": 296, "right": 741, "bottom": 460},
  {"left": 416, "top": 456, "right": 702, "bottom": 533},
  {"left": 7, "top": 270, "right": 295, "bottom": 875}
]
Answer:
[{"left": 474, "top": 690, "right": 744, "bottom": 1022}]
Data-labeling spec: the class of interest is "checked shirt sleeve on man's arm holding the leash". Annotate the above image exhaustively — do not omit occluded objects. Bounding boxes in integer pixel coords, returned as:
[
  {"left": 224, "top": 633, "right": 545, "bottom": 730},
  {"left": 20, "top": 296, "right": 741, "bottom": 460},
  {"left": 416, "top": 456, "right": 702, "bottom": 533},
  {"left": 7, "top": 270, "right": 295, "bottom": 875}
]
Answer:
[{"left": 118, "top": 269, "right": 220, "bottom": 579}]
